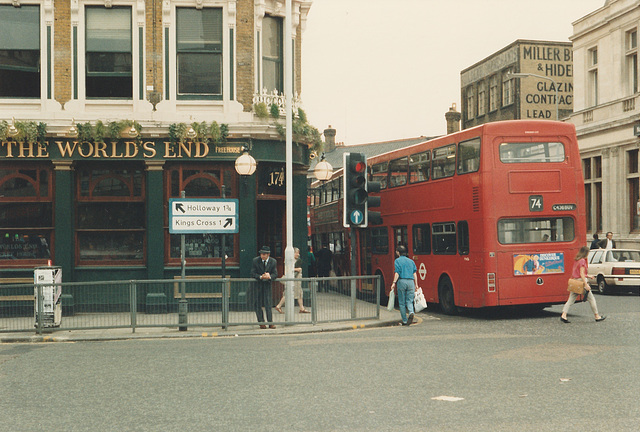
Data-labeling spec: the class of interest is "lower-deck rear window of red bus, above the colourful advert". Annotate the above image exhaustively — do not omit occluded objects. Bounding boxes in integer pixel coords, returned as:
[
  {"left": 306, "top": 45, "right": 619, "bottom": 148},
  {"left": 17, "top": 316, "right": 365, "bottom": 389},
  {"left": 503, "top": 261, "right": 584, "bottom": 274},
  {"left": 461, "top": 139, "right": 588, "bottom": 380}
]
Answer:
[{"left": 498, "top": 217, "right": 576, "bottom": 244}]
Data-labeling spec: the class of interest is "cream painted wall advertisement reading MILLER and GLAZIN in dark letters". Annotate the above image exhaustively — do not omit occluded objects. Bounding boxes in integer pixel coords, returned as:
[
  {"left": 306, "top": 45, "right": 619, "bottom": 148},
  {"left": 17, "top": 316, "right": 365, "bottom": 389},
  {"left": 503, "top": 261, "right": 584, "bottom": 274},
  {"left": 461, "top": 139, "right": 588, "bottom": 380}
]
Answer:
[{"left": 520, "top": 44, "right": 573, "bottom": 120}]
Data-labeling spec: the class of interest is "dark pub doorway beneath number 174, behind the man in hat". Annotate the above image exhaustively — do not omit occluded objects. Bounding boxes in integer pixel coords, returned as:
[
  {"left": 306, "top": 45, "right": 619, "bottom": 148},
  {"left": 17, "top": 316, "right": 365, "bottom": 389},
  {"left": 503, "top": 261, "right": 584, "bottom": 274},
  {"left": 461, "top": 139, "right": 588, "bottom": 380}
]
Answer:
[{"left": 256, "top": 200, "right": 286, "bottom": 277}]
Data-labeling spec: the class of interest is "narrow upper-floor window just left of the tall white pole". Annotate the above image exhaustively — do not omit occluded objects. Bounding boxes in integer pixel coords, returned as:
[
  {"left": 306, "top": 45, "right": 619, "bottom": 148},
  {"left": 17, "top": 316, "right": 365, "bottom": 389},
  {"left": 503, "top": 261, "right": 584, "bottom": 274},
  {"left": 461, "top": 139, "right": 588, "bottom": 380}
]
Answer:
[{"left": 262, "top": 16, "right": 284, "bottom": 93}]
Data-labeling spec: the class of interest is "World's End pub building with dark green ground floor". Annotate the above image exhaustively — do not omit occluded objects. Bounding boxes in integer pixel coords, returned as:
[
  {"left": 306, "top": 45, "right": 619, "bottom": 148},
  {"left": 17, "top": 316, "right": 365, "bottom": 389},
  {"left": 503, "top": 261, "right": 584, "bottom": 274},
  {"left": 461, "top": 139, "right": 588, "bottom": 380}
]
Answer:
[{"left": 0, "top": 0, "right": 319, "bottom": 294}]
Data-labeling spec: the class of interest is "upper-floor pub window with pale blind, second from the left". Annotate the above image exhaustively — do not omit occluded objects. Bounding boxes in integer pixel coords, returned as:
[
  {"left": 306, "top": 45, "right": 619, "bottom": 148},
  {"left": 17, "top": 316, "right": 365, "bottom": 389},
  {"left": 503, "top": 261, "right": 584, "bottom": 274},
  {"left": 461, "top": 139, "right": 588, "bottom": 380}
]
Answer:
[{"left": 86, "top": 6, "right": 133, "bottom": 99}]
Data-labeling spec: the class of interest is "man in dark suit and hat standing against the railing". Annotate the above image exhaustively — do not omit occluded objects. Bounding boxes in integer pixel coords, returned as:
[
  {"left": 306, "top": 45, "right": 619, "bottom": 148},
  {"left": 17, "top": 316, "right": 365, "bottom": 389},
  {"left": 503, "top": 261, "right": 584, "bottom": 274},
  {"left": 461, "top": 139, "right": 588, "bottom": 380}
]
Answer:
[{"left": 251, "top": 246, "right": 278, "bottom": 329}]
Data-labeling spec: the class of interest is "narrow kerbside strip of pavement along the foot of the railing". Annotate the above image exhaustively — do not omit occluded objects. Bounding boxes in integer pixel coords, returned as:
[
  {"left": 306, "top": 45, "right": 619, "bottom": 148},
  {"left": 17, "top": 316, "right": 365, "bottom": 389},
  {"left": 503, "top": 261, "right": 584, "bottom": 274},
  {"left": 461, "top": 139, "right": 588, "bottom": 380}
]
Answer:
[{"left": 0, "top": 307, "right": 427, "bottom": 343}]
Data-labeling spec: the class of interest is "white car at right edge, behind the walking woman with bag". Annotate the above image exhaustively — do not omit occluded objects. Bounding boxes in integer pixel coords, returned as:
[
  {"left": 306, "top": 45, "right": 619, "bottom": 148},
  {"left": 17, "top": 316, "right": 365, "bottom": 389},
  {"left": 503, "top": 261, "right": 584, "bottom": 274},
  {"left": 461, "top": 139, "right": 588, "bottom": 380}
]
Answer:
[{"left": 587, "top": 249, "right": 640, "bottom": 294}]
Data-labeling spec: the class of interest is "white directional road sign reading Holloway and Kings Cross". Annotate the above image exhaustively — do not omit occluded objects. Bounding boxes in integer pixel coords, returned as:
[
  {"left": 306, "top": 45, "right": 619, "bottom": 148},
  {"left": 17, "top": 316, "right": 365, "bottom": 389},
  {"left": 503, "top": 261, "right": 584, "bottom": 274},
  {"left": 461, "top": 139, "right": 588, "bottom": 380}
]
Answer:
[{"left": 169, "top": 198, "right": 238, "bottom": 234}]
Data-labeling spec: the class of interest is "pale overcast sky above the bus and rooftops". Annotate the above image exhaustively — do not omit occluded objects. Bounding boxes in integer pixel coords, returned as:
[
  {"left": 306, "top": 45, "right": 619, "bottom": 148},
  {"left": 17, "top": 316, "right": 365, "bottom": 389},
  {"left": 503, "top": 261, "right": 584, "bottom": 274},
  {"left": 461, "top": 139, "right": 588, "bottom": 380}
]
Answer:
[{"left": 301, "top": 0, "right": 605, "bottom": 145}]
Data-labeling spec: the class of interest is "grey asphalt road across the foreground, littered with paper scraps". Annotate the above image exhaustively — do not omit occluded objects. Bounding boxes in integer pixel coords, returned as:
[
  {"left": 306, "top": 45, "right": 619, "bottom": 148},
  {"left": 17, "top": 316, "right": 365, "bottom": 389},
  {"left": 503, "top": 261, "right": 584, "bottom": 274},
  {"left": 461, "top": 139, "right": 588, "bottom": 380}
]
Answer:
[{"left": 0, "top": 294, "right": 640, "bottom": 432}]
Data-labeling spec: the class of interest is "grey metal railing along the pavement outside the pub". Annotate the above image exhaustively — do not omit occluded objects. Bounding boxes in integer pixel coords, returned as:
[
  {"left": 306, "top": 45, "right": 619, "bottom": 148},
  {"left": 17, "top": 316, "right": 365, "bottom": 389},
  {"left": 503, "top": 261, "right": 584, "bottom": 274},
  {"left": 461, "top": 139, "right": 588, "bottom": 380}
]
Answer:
[{"left": 0, "top": 276, "right": 380, "bottom": 334}]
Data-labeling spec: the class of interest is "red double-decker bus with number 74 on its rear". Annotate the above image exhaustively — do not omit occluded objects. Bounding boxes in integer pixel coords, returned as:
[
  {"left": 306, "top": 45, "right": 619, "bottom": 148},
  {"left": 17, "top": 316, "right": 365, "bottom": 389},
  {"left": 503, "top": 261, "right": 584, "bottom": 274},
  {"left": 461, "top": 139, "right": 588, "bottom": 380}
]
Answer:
[{"left": 358, "top": 120, "right": 586, "bottom": 314}]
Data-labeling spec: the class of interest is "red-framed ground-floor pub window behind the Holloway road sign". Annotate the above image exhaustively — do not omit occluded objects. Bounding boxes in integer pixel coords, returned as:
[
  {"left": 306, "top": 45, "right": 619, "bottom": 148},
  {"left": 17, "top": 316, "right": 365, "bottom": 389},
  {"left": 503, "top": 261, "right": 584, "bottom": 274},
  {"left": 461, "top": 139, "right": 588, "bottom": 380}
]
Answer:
[{"left": 165, "top": 164, "right": 238, "bottom": 265}]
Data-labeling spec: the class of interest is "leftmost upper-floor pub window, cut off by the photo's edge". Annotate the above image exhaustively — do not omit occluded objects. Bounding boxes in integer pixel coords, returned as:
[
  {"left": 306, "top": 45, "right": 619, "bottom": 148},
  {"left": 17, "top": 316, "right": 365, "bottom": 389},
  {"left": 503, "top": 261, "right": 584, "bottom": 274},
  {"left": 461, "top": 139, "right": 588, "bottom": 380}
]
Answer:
[{"left": 0, "top": 4, "right": 40, "bottom": 98}]
